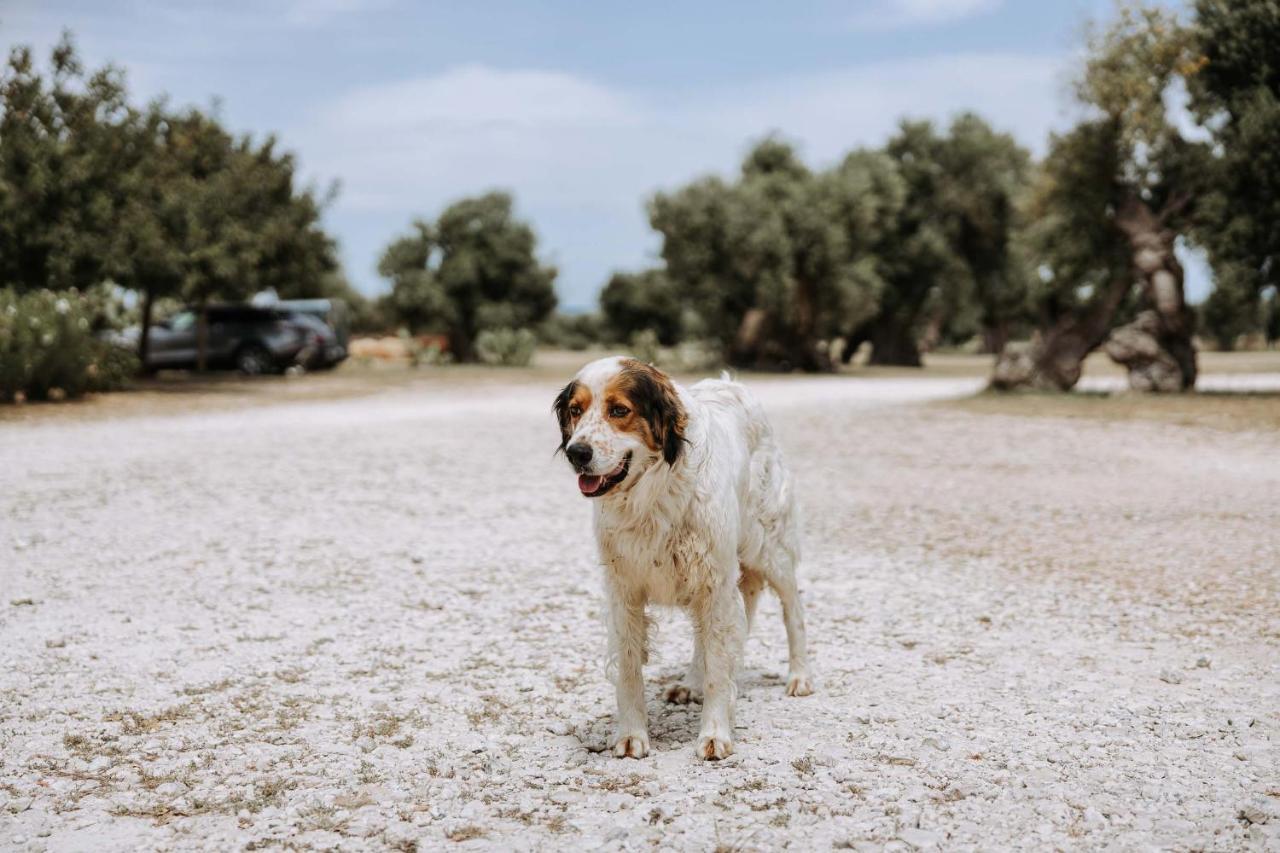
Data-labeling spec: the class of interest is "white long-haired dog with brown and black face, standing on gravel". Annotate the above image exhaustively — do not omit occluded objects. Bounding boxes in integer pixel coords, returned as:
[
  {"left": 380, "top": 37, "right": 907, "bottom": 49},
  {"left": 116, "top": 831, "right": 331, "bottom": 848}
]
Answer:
[{"left": 554, "top": 357, "right": 813, "bottom": 761}]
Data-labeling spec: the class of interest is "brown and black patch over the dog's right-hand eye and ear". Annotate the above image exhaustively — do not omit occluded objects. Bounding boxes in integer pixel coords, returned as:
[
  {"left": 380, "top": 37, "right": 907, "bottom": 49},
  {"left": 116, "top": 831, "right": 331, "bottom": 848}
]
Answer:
[{"left": 602, "top": 359, "right": 689, "bottom": 465}]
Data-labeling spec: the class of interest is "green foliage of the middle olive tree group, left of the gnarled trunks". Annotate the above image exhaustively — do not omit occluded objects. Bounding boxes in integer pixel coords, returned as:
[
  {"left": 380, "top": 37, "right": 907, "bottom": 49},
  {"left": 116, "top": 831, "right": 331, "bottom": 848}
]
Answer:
[{"left": 650, "top": 115, "right": 1030, "bottom": 369}]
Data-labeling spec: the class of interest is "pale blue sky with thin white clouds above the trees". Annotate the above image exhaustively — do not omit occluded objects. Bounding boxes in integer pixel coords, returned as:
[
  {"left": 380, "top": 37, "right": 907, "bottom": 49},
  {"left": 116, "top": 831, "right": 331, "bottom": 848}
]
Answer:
[{"left": 0, "top": 0, "right": 1208, "bottom": 310}]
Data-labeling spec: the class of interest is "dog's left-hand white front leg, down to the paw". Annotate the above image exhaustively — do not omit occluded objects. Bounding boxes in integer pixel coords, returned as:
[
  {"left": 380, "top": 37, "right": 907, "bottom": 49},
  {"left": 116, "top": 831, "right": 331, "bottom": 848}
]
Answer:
[{"left": 609, "top": 588, "right": 649, "bottom": 758}]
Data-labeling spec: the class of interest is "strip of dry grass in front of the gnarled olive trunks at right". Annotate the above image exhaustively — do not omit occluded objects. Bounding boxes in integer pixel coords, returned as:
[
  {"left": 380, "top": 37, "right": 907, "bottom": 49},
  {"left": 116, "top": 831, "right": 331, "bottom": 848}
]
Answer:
[{"left": 934, "top": 393, "right": 1280, "bottom": 432}]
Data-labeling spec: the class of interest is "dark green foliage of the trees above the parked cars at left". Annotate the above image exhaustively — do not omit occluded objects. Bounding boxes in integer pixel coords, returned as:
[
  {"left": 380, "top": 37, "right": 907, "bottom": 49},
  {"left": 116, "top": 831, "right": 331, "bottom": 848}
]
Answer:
[{"left": 0, "top": 36, "right": 337, "bottom": 368}]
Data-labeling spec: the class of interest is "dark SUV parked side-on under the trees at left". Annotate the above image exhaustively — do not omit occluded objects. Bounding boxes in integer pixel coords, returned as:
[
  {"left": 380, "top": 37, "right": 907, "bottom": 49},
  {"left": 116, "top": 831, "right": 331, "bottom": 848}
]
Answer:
[{"left": 115, "top": 305, "right": 324, "bottom": 375}]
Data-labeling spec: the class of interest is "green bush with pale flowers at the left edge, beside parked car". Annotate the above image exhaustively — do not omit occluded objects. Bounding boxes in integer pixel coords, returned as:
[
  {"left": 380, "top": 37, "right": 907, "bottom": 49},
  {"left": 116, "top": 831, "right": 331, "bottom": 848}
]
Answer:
[{"left": 0, "top": 289, "right": 137, "bottom": 402}]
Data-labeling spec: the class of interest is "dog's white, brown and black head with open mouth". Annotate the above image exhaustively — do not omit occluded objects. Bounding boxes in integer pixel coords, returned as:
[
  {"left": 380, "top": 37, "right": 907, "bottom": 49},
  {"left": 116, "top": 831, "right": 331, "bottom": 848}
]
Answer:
[{"left": 554, "top": 357, "right": 689, "bottom": 497}]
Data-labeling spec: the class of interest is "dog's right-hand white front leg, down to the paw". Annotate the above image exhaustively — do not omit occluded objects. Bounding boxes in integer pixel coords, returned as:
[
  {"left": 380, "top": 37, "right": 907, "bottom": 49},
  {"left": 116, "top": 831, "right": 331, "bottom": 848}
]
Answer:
[{"left": 694, "top": 573, "right": 746, "bottom": 761}]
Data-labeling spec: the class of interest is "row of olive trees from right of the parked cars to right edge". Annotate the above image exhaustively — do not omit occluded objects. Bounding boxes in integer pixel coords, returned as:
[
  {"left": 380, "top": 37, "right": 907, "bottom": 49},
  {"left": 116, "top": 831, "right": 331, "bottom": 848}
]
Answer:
[{"left": 381, "top": 0, "right": 1280, "bottom": 391}]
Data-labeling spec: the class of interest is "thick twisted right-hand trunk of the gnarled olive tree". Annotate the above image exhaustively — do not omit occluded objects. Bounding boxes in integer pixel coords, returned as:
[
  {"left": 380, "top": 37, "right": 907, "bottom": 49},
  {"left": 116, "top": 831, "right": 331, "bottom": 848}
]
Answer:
[{"left": 1105, "top": 197, "right": 1196, "bottom": 392}]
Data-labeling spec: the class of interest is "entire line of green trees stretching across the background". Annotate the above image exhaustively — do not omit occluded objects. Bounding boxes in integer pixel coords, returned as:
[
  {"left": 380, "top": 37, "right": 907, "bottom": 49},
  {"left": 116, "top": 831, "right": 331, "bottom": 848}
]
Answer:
[{"left": 0, "top": 0, "right": 1280, "bottom": 391}]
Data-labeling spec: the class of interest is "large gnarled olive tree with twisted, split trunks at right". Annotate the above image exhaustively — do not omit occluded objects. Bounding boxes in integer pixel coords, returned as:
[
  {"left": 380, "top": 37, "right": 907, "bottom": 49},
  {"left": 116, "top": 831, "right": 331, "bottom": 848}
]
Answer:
[{"left": 992, "top": 5, "right": 1207, "bottom": 391}]
